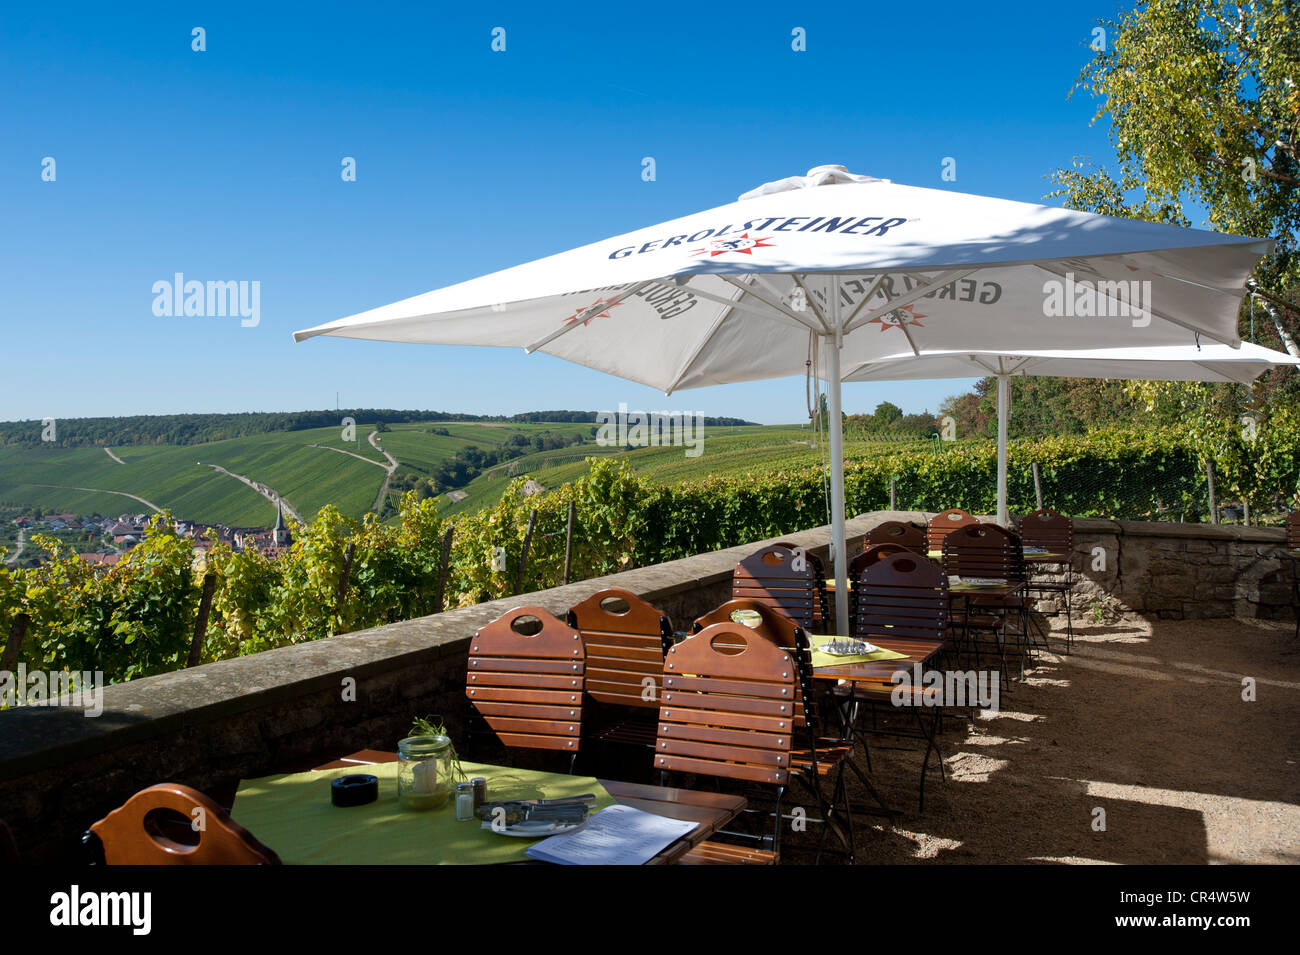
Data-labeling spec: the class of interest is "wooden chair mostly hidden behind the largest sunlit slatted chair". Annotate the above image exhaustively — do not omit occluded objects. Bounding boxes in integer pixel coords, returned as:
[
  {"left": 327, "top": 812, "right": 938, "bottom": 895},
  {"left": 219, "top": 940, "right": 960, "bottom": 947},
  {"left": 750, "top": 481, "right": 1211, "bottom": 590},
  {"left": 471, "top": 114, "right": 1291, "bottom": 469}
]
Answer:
[{"left": 693, "top": 599, "right": 870, "bottom": 865}]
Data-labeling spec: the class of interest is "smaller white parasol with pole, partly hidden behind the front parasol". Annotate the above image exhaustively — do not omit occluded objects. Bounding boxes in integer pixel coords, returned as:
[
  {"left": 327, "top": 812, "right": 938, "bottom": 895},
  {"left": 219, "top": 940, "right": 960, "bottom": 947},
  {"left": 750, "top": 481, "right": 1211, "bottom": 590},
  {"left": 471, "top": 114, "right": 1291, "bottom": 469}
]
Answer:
[{"left": 844, "top": 342, "right": 1300, "bottom": 525}]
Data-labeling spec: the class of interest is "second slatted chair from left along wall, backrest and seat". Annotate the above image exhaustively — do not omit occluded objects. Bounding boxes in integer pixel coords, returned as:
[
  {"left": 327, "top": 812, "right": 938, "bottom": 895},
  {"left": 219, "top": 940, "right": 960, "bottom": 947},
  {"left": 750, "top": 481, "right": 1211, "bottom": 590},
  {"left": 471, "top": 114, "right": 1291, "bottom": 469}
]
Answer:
[{"left": 566, "top": 587, "right": 672, "bottom": 747}]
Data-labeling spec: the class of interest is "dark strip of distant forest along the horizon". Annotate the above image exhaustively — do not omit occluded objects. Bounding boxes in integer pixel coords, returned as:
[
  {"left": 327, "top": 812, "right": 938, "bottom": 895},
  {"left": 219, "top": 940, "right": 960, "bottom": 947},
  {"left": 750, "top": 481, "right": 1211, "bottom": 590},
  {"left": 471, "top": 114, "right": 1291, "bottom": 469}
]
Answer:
[{"left": 0, "top": 408, "right": 754, "bottom": 448}]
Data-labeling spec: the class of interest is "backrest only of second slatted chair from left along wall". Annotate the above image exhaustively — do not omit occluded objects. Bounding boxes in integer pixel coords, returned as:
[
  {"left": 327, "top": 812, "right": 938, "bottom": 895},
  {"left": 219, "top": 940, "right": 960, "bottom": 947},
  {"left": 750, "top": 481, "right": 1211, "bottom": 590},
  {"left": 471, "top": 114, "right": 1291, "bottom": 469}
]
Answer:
[{"left": 567, "top": 587, "right": 672, "bottom": 709}]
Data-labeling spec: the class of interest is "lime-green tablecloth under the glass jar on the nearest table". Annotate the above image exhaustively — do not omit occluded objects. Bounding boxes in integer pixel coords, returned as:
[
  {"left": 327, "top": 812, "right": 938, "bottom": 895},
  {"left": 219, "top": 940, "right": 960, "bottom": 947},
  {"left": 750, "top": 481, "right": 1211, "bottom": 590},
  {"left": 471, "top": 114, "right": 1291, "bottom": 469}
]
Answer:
[{"left": 230, "top": 763, "right": 615, "bottom": 865}]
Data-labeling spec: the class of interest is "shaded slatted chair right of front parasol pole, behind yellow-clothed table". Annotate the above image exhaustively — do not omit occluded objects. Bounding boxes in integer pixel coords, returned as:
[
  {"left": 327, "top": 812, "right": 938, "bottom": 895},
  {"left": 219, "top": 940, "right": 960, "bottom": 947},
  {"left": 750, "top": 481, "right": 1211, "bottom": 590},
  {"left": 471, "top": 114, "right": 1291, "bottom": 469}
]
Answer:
[{"left": 852, "top": 551, "right": 950, "bottom": 812}]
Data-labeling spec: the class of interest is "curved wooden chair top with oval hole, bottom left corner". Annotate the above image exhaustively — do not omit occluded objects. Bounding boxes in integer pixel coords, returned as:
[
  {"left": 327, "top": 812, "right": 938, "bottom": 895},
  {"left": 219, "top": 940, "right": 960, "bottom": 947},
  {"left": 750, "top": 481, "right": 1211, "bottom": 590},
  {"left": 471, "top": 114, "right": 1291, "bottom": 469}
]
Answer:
[{"left": 83, "top": 782, "right": 280, "bottom": 865}]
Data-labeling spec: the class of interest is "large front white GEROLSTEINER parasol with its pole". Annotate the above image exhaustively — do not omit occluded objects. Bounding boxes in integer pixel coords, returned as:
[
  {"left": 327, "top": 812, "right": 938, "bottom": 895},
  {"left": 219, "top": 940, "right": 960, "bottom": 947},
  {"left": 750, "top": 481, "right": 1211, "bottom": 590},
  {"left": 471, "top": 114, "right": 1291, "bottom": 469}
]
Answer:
[{"left": 294, "top": 166, "right": 1273, "bottom": 633}]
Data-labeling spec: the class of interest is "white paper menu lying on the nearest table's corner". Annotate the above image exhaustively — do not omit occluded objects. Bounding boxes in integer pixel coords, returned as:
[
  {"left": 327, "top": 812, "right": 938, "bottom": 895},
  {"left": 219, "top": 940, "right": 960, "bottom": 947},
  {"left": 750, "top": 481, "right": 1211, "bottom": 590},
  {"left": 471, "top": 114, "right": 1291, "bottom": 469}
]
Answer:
[{"left": 528, "top": 806, "right": 698, "bottom": 865}]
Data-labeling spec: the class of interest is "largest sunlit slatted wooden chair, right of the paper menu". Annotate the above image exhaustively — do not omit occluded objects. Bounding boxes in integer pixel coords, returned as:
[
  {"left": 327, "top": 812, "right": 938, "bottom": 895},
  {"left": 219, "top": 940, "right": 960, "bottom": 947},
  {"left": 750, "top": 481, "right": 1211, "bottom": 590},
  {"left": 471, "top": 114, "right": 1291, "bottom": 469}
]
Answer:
[{"left": 654, "top": 622, "right": 798, "bottom": 861}]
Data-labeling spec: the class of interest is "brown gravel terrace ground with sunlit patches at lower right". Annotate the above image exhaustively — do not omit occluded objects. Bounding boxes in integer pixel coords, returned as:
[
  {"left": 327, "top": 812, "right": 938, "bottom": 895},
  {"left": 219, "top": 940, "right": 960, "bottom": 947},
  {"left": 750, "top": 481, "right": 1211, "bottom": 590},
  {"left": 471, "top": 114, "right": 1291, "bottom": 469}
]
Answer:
[{"left": 790, "top": 618, "right": 1300, "bottom": 864}]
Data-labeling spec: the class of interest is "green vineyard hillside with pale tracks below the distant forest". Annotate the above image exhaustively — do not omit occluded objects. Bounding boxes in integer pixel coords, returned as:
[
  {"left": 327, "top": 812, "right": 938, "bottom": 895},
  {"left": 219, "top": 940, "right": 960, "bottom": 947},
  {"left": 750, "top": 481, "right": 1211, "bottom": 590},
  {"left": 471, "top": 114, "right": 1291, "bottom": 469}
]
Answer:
[{"left": 0, "top": 420, "right": 935, "bottom": 526}]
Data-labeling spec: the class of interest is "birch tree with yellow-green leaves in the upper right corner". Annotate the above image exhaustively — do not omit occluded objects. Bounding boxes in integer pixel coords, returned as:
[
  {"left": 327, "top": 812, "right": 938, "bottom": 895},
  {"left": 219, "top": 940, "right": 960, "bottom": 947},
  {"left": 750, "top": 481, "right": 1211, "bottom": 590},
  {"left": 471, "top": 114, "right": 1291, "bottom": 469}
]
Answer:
[{"left": 1050, "top": 0, "right": 1300, "bottom": 337}]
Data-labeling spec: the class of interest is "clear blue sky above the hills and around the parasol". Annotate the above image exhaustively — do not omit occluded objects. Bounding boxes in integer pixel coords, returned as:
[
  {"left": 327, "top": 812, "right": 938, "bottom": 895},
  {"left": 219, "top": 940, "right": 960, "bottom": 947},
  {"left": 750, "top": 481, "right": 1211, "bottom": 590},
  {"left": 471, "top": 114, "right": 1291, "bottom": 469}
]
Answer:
[{"left": 0, "top": 3, "right": 1118, "bottom": 422}]
